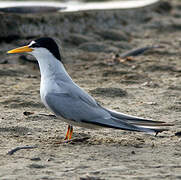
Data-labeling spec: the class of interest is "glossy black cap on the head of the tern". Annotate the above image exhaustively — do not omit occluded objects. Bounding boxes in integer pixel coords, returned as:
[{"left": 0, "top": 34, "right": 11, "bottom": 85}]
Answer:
[{"left": 30, "top": 37, "right": 61, "bottom": 61}]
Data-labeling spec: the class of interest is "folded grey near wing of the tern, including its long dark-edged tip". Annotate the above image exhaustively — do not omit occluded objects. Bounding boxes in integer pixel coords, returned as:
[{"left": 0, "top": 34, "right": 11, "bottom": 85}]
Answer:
[{"left": 45, "top": 89, "right": 155, "bottom": 132}]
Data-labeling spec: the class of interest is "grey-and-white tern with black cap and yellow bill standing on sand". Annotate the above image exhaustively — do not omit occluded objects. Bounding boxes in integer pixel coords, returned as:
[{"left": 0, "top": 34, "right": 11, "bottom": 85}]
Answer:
[{"left": 7, "top": 37, "right": 170, "bottom": 140}]
